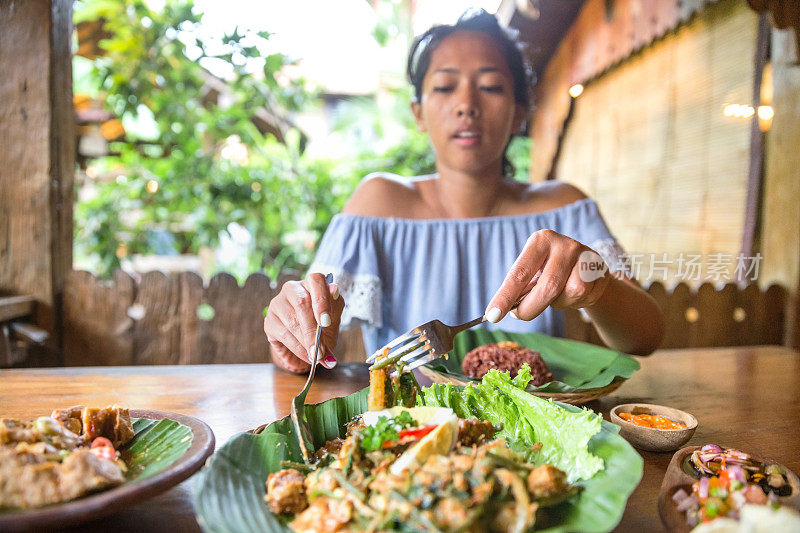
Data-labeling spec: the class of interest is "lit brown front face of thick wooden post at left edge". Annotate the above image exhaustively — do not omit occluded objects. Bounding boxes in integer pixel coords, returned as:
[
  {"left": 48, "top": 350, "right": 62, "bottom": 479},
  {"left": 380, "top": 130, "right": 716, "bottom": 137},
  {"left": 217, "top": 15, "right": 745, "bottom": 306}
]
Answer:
[{"left": 0, "top": 0, "right": 52, "bottom": 329}]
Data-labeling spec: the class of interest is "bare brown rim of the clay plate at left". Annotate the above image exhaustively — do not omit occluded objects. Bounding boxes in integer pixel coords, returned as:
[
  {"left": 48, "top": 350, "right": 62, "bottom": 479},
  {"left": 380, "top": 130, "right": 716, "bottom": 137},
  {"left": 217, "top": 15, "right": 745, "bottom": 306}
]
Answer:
[{"left": 0, "top": 409, "right": 214, "bottom": 532}]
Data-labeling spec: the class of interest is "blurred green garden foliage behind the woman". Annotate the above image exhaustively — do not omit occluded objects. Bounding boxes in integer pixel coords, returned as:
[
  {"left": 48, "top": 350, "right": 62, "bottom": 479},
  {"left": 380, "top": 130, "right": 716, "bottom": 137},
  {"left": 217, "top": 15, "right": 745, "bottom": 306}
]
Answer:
[{"left": 74, "top": 0, "right": 527, "bottom": 279}]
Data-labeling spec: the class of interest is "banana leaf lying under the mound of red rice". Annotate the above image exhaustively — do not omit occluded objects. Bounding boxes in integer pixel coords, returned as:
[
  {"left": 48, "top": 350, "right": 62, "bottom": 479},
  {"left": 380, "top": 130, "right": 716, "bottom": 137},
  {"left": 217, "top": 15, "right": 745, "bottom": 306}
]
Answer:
[{"left": 427, "top": 328, "right": 640, "bottom": 393}]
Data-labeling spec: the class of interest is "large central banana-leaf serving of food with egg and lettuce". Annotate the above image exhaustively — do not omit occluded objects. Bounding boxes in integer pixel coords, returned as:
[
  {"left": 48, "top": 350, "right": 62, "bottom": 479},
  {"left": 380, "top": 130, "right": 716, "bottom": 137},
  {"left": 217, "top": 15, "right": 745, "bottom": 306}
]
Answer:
[{"left": 194, "top": 358, "right": 642, "bottom": 532}]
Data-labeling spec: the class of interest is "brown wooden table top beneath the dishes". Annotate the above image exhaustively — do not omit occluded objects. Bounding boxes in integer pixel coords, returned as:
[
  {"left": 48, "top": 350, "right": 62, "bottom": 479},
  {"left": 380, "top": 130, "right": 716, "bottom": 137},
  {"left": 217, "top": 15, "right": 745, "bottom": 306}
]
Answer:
[{"left": 0, "top": 346, "right": 800, "bottom": 532}]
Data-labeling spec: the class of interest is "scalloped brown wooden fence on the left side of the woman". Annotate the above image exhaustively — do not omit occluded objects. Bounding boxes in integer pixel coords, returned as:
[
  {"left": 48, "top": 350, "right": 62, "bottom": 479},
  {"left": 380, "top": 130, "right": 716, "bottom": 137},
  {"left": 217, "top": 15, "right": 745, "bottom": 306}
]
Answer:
[{"left": 64, "top": 271, "right": 364, "bottom": 366}]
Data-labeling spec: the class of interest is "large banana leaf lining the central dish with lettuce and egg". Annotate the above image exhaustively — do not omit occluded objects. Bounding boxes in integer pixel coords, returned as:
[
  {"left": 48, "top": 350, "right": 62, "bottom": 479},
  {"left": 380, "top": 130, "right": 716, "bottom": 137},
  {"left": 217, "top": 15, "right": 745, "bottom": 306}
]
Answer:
[{"left": 194, "top": 389, "right": 642, "bottom": 533}]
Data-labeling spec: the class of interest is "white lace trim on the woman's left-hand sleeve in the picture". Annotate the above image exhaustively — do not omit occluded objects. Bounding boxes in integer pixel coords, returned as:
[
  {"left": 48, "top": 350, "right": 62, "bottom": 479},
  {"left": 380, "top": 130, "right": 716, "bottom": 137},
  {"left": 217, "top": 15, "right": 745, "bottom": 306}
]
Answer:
[{"left": 309, "top": 264, "right": 383, "bottom": 329}]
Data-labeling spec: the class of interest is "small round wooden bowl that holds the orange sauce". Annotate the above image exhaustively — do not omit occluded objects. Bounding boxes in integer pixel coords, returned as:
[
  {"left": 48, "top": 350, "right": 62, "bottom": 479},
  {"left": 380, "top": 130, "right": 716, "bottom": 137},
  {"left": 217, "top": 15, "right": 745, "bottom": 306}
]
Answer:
[{"left": 611, "top": 403, "right": 697, "bottom": 452}]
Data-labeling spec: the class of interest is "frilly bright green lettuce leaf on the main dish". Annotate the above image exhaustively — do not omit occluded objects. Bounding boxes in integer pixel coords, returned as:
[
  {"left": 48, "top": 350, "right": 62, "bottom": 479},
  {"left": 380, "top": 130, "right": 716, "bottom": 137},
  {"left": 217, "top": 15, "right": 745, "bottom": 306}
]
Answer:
[{"left": 422, "top": 364, "right": 603, "bottom": 483}]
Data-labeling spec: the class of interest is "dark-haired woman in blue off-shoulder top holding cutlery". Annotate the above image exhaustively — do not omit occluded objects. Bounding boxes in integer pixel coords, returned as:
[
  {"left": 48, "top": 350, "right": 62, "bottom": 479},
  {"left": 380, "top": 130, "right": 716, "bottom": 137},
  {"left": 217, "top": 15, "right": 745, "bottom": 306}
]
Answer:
[{"left": 264, "top": 11, "right": 663, "bottom": 372}]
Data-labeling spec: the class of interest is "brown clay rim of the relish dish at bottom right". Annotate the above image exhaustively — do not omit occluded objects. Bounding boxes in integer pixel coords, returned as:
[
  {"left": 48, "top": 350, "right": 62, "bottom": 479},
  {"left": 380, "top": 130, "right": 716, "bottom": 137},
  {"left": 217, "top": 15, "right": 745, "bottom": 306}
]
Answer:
[{"left": 658, "top": 445, "right": 800, "bottom": 533}]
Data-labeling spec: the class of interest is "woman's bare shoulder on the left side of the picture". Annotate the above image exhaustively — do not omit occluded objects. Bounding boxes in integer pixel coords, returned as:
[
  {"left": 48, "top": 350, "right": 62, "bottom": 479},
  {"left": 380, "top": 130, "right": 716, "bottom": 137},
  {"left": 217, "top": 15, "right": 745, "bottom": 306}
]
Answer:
[{"left": 342, "top": 172, "right": 426, "bottom": 217}]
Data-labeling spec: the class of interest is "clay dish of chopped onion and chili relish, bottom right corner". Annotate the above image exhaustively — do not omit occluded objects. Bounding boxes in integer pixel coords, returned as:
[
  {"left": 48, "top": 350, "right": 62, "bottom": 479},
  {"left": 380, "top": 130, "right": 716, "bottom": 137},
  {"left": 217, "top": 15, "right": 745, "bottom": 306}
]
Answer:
[{"left": 658, "top": 444, "right": 800, "bottom": 532}]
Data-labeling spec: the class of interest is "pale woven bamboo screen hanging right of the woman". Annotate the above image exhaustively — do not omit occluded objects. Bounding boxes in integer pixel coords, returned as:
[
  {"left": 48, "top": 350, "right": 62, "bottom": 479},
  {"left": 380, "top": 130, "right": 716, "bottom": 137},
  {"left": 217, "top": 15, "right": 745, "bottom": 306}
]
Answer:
[{"left": 556, "top": 2, "right": 758, "bottom": 284}]
